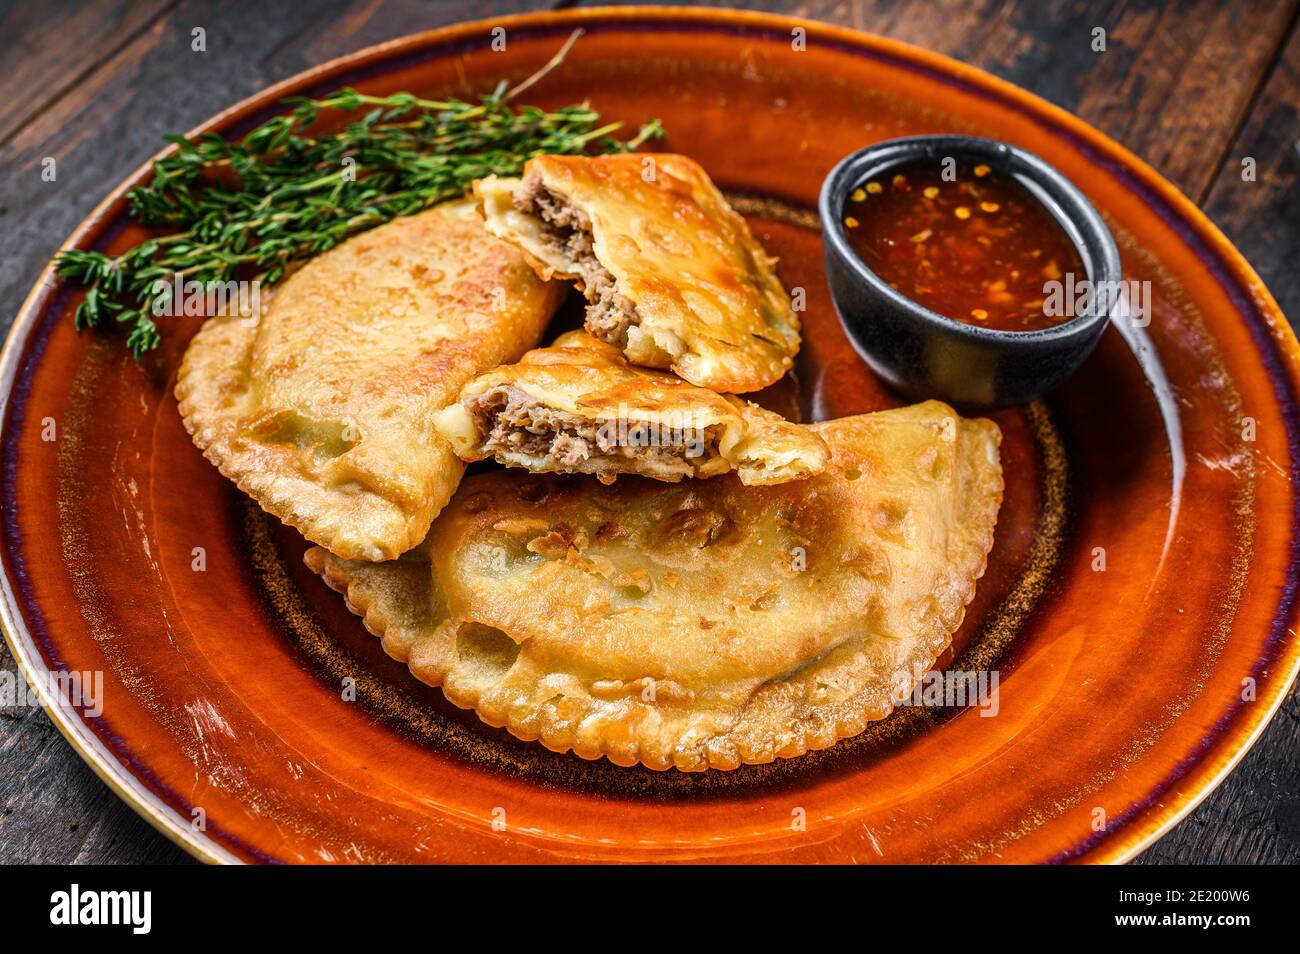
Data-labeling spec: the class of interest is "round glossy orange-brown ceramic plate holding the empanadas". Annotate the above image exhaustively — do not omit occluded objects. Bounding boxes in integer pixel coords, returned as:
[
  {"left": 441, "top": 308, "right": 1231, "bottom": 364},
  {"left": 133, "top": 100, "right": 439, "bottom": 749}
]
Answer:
[{"left": 0, "top": 8, "right": 1300, "bottom": 862}]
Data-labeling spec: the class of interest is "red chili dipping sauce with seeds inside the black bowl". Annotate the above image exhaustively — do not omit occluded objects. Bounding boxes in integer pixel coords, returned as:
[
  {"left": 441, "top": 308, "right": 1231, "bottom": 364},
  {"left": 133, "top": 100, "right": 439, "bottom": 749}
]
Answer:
[{"left": 844, "top": 160, "right": 1088, "bottom": 331}]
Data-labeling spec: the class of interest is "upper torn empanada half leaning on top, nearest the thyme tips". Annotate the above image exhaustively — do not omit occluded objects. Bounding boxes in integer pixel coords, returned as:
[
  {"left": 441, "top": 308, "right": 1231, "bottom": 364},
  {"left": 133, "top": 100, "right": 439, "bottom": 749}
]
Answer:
[{"left": 475, "top": 153, "right": 800, "bottom": 394}]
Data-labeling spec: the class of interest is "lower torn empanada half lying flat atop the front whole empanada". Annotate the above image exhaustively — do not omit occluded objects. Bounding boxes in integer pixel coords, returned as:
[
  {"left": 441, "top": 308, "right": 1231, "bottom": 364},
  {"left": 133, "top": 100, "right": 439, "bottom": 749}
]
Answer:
[{"left": 434, "top": 331, "right": 829, "bottom": 483}]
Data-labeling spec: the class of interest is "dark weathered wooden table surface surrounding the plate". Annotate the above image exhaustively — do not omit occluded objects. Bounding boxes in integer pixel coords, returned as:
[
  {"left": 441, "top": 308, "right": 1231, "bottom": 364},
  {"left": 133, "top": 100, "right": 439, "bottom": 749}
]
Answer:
[{"left": 0, "top": 0, "right": 1300, "bottom": 863}]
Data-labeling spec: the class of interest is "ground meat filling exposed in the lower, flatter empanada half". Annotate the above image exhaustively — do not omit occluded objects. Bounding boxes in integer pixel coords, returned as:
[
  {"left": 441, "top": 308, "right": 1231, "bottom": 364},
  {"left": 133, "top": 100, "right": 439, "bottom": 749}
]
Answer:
[{"left": 469, "top": 386, "right": 722, "bottom": 477}]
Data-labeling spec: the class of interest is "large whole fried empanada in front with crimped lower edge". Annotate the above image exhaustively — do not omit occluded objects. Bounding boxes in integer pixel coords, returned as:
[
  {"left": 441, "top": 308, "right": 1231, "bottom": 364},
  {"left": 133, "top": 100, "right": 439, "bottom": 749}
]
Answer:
[{"left": 306, "top": 402, "right": 1002, "bottom": 771}]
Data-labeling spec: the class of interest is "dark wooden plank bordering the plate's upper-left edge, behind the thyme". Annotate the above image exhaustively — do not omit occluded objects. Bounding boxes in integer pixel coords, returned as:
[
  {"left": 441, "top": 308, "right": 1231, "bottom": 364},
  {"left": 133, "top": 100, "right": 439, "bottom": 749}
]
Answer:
[{"left": 0, "top": 0, "right": 553, "bottom": 343}]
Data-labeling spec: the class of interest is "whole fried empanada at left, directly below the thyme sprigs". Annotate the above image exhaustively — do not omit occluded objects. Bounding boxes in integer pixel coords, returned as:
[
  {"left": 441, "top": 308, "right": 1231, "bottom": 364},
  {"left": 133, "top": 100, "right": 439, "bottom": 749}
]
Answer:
[{"left": 176, "top": 201, "right": 562, "bottom": 560}]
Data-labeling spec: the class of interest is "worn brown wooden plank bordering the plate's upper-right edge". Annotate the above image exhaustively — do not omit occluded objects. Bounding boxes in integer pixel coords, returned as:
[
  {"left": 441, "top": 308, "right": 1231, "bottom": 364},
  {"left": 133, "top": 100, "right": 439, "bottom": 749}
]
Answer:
[{"left": 585, "top": 0, "right": 1296, "bottom": 198}]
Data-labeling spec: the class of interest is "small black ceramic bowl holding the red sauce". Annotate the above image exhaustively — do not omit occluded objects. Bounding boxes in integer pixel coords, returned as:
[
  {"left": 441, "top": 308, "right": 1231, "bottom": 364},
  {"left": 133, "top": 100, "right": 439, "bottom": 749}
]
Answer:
[{"left": 820, "top": 135, "right": 1122, "bottom": 409}]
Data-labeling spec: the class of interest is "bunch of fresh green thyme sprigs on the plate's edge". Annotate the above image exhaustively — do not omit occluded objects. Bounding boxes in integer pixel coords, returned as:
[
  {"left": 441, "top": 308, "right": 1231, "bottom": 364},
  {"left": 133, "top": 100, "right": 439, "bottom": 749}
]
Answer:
[{"left": 59, "top": 64, "right": 663, "bottom": 359}]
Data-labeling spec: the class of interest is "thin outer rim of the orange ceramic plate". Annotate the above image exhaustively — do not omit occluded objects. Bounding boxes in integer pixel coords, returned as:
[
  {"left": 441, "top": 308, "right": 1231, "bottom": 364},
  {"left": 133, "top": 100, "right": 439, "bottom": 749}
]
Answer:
[{"left": 0, "top": 5, "right": 1300, "bottom": 863}]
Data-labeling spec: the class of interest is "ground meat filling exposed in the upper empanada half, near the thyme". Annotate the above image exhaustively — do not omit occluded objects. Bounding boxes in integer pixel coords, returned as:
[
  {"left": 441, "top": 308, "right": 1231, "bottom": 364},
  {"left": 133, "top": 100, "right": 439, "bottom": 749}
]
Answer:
[{"left": 515, "top": 175, "right": 640, "bottom": 348}]
